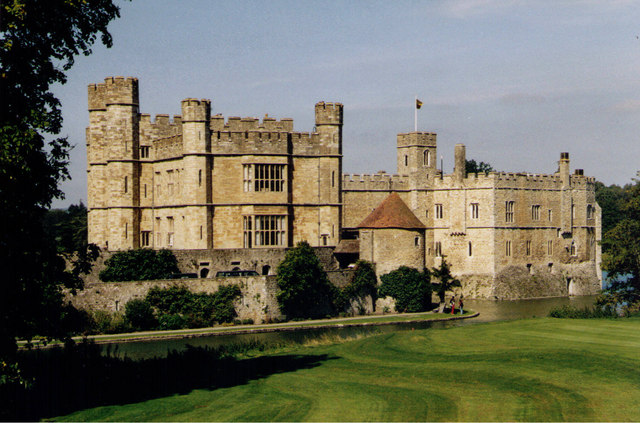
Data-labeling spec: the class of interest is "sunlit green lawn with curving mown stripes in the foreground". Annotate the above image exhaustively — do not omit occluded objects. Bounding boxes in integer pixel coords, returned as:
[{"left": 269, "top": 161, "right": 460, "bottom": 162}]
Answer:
[{"left": 53, "top": 318, "right": 640, "bottom": 421}]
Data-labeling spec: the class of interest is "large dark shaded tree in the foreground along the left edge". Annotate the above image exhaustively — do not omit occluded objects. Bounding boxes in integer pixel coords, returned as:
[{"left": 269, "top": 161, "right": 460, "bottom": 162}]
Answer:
[{"left": 0, "top": 0, "right": 119, "bottom": 361}]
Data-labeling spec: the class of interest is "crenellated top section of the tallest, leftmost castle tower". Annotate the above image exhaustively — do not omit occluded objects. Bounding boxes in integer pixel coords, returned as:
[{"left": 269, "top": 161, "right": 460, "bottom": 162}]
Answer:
[{"left": 88, "top": 76, "right": 139, "bottom": 111}]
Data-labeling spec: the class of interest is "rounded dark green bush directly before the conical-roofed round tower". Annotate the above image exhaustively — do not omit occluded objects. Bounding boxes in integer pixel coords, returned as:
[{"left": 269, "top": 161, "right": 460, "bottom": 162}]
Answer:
[{"left": 378, "top": 266, "right": 431, "bottom": 313}]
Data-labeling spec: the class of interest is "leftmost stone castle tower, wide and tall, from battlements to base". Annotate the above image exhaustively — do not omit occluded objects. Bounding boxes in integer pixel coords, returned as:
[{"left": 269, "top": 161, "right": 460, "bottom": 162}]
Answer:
[{"left": 87, "top": 77, "right": 140, "bottom": 250}]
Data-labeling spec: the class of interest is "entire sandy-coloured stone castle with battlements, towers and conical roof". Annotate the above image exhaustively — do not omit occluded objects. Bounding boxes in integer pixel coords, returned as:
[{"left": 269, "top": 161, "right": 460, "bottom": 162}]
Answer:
[{"left": 87, "top": 77, "right": 601, "bottom": 299}]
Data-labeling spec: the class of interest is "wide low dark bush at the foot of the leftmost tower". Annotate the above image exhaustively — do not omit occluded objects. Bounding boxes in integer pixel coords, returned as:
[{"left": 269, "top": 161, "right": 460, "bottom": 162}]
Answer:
[{"left": 100, "top": 248, "right": 180, "bottom": 282}]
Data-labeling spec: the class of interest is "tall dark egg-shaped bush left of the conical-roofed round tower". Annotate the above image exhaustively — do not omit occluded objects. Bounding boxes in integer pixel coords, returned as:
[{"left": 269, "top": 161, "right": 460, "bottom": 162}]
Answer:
[{"left": 277, "top": 241, "right": 334, "bottom": 318}]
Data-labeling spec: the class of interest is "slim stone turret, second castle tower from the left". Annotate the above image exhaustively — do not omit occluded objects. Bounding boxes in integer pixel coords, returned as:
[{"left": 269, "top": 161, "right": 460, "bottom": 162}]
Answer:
[{"left": 181, "top": 98, "right": 213, "bottom": 249}]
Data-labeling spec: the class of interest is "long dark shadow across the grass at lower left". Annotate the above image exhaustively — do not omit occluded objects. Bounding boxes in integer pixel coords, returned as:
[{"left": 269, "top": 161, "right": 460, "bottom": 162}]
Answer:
[{"left": 0, "top": 343, "right": 330, "bottom": 421}]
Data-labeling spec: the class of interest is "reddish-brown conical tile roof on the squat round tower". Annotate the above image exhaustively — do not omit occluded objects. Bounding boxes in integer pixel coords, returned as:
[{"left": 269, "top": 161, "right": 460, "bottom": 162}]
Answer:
[{"left": 358, "top": 192, "right": 425, "bottom": 229}]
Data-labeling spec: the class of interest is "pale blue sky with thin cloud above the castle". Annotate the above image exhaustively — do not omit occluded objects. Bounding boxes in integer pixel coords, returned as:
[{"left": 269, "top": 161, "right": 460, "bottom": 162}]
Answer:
[{"left": 54, "top": 0, "right": 640, "bottom": 207}]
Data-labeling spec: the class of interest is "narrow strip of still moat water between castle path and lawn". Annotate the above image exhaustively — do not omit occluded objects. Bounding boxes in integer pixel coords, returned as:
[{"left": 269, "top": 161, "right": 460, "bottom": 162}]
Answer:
[{"left": 109, "top": 296, "right": 596, "bottom": 359}]
